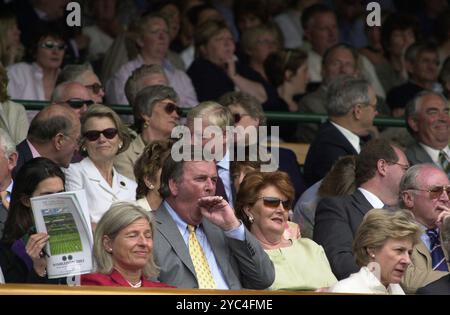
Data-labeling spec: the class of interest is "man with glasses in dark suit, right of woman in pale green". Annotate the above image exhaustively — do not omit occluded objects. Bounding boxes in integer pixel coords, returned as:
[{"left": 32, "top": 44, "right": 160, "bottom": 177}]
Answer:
[{"left": 313, "top": 139, "right": 409, "bottom": 280}]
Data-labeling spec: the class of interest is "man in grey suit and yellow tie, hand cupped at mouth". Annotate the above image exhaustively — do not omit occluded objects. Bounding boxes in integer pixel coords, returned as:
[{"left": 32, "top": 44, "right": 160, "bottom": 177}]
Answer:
[{"left": 153, "top": 146, "right": 275, "bottom": 289}]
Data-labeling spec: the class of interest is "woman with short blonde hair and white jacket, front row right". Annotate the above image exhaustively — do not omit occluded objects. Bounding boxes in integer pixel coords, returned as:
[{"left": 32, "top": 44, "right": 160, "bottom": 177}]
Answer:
[{"left": 330, "top": 209, "right": 421, "bottom": 295}]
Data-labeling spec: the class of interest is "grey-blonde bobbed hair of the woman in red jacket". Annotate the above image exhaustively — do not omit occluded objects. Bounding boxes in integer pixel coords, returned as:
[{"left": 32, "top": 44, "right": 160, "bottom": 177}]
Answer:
[{"left": 93, "top": 202, "right": 159, "bottom": 279}]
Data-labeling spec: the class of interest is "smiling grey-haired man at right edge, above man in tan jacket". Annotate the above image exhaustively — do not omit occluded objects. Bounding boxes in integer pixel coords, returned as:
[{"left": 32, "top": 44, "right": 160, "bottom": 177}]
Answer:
[{"left": 405, "top": 91, "right": 450, "bottom": 173}]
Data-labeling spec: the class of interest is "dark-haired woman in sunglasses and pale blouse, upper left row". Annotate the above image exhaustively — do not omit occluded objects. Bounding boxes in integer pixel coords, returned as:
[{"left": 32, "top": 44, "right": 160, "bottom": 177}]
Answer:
[{"left": 7, "top": 29, "right": 66, "bottom": 101}]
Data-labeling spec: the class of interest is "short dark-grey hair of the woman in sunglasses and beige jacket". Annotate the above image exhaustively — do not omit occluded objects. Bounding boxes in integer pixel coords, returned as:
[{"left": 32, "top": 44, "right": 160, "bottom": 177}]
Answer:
[{"left": 133, "top": 85, "right": 179, "bottom": 133}]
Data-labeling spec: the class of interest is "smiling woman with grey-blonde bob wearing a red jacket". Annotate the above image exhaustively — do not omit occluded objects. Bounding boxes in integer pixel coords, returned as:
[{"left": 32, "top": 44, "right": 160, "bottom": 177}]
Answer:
[{"left": 81, "top": 202, "right": 170, "bottom": 288}]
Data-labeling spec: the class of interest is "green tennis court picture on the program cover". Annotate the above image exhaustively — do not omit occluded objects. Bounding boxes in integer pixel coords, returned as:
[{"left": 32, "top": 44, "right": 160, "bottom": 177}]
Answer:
[{"left": 44, "top": 213, "right": 83, "bottom": 255}]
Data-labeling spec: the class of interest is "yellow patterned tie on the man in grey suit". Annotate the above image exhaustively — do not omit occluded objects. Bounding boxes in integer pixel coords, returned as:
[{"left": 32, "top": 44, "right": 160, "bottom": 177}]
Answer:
[{"left": 188, "top": 225, "right": 216, "bottom": 289}]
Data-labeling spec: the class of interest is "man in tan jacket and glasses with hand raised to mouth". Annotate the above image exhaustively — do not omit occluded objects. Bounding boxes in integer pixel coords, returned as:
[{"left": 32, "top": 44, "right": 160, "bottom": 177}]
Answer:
[{"left": 400, "top": 164, "right": 450, "bottom": 293}]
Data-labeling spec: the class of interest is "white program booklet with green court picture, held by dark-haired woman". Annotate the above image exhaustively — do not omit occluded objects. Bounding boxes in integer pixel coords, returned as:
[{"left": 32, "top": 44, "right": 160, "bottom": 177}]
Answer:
[{"left": 30, "top": 190, "right": 93, "bottom": 279}]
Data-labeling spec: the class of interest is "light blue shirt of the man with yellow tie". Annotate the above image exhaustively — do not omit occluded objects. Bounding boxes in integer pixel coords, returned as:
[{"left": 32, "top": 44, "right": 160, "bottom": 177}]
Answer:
[{"left": 164, "top": 201, "right": 245, "bottom": 290}]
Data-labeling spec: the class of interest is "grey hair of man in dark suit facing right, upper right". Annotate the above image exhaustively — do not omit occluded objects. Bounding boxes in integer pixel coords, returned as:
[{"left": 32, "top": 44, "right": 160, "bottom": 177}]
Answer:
[{"left": 326, "top": 75, "right": 370, "bottom": 117}]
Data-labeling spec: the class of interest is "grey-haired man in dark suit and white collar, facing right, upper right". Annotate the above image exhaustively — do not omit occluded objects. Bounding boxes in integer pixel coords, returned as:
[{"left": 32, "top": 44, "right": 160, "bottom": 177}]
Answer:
[{"left": 304, "top": 76, "right": 377, "bottom": 186}]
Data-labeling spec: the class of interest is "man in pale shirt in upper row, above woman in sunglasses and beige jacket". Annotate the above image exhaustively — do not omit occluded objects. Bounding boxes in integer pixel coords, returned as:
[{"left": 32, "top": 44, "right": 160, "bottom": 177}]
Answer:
[{"left": 106, "top": 13, "right": 198, "bottom": 107}]
